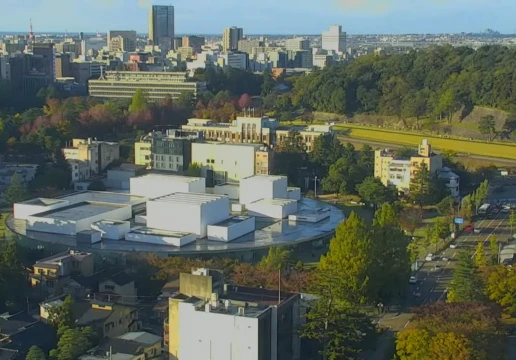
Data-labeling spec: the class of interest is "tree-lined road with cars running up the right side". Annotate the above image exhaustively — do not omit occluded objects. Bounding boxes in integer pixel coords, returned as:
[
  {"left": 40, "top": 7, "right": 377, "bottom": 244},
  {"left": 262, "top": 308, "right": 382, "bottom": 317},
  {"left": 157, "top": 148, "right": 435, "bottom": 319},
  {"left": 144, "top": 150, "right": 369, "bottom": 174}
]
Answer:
[{"left": 369, "top": 212, "right": 516, "bottom": 360}]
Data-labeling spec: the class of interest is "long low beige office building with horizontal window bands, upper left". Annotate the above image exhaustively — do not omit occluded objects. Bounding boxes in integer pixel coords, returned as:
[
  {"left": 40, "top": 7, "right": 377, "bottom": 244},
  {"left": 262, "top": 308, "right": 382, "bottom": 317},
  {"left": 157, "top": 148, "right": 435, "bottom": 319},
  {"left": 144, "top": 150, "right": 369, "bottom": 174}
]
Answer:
[{"left": 89, "top": 71, "right": 206, "bottom": 101}]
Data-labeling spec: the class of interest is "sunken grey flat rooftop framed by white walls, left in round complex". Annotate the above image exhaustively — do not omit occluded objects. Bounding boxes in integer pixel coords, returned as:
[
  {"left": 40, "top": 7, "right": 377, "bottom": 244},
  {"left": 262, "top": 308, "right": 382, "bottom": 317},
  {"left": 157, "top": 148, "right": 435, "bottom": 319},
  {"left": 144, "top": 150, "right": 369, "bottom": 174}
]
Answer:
[{"left": 32, "top": 201, "right": 123, "bottom": 221}]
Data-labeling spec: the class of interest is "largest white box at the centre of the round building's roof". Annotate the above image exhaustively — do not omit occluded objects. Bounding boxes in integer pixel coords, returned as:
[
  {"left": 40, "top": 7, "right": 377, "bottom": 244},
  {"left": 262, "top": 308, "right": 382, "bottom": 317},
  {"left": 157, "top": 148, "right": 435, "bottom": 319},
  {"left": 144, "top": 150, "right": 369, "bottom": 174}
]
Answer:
[{"left": 143, "top": 193, "right": 230, "bottom": 238}]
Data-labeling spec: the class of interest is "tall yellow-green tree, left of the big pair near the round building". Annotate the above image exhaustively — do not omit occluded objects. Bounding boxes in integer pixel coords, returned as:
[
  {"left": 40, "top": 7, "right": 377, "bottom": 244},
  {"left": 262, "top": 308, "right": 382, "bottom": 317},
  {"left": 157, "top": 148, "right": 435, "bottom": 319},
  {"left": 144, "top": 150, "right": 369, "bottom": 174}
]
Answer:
[{"left": 314, "top": 212, "right": 373, "bottom": 305}]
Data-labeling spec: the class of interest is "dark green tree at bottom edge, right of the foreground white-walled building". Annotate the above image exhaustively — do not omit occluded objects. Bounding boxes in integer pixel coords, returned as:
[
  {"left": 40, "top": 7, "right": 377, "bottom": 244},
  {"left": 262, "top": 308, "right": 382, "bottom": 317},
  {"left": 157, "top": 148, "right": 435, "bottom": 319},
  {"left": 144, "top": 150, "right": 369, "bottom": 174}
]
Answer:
[{"left": 301, "top": 298, "right": 376, "bottom": 360}]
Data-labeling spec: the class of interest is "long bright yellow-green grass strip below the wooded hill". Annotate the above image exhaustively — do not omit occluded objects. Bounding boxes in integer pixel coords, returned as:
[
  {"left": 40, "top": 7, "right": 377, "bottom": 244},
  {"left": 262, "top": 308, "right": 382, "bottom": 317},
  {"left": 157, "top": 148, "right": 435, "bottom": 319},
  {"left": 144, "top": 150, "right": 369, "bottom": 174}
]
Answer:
[{"left": 335, "top": 124, "right": 516, "bottom": 159}]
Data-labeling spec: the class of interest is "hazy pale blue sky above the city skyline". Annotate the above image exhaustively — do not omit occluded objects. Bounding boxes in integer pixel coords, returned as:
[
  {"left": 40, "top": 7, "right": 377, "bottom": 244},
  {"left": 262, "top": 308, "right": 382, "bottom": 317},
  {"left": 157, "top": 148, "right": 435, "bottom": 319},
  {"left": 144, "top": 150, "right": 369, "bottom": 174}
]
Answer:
[{"left": 0, "top": 0, "right": 516, "bottom": 34}]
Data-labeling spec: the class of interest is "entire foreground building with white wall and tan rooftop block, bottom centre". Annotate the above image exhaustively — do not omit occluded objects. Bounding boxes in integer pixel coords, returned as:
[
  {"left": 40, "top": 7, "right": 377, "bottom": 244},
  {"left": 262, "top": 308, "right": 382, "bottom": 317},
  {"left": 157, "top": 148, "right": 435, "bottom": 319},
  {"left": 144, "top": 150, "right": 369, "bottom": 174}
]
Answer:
[{"left": 168, "top": 269, "right": 302, "bottom": 360}]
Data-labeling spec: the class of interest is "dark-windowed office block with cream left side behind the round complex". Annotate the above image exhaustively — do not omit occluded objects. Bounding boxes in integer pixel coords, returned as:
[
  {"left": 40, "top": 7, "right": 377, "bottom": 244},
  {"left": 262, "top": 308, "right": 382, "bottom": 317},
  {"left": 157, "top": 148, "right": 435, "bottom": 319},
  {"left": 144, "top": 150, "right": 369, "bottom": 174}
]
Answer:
[{"left": 134, "top": 129, "right": 202, "bottom": 172}]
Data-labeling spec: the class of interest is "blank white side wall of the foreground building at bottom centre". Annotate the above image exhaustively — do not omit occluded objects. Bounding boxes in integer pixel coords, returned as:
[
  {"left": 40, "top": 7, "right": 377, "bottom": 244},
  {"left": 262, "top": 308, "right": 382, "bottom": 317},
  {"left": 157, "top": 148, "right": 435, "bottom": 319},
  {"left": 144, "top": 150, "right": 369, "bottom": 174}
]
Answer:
[{"left": 178, "top": 302, "right": 259, "bottom": 360}]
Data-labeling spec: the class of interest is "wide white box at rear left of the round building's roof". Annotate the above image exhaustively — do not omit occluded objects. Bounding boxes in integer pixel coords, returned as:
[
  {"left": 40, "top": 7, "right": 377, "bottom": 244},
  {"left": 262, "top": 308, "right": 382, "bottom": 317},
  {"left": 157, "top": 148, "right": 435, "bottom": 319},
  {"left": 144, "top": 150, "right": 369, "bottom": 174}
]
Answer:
[{"left": 129, "top": 174, "right": 206, "bottom": 199}]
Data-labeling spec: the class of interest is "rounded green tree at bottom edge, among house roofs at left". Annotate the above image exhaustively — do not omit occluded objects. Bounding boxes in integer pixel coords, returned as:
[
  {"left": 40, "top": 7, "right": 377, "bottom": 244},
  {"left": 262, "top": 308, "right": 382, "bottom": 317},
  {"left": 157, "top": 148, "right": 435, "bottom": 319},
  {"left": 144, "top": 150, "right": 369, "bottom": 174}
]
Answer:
[{"left": 50, "top": 327, "right": 93, "bottom": 360}]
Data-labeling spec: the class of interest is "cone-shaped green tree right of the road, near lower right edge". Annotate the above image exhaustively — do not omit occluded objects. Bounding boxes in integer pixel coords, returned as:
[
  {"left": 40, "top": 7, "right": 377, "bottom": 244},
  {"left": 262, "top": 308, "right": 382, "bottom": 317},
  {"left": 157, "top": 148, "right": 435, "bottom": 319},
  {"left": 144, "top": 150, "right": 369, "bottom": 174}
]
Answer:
[{"left": 448, "top": 251, "right": 483, "bottom": 302}]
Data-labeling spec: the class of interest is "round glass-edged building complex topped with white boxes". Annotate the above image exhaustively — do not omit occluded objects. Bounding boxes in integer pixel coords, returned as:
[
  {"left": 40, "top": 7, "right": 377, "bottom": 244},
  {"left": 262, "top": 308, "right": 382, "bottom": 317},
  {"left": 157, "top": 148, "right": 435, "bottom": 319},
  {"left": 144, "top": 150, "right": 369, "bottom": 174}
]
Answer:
[{"left": 7, "top": 173, "right": 344, "bottom": 259}]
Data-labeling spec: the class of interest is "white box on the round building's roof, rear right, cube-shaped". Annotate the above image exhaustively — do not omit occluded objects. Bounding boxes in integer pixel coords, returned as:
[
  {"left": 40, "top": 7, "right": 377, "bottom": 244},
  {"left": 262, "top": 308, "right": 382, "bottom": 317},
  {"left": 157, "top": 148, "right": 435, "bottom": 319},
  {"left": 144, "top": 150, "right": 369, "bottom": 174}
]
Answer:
[{"left": 240, "top": 175, "right": 288, "bottom": 205}]
